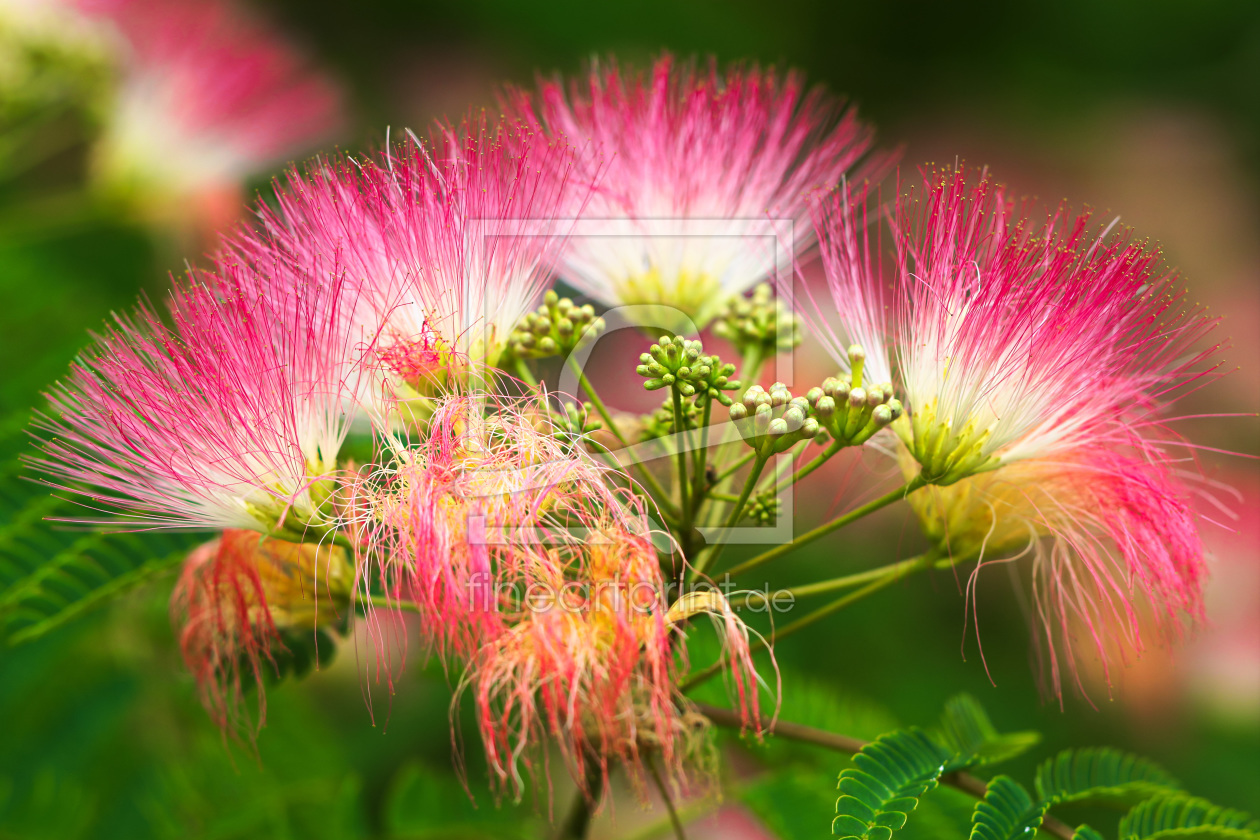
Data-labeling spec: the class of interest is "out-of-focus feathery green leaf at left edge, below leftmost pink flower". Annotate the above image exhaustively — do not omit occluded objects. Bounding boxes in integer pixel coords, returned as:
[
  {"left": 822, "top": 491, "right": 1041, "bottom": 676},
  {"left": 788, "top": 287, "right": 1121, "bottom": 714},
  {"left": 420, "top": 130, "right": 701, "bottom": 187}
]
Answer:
[{"left": 0, "top": 525, "right": 202, "bottom": 645}]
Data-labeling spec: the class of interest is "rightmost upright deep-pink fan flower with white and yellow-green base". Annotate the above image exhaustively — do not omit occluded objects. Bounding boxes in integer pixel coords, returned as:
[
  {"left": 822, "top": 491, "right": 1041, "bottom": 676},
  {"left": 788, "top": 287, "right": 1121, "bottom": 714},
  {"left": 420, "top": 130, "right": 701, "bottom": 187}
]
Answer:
[{"left": 893, "top": 170, "right": 1217, "bottom": 484}]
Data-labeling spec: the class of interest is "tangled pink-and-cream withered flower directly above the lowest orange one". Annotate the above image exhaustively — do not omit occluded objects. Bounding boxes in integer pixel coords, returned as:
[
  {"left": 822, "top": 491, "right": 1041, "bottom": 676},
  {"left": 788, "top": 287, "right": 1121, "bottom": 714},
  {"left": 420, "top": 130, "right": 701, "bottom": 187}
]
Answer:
[{"left": 350, "top": 397, "right": 646, "bottom": 657}]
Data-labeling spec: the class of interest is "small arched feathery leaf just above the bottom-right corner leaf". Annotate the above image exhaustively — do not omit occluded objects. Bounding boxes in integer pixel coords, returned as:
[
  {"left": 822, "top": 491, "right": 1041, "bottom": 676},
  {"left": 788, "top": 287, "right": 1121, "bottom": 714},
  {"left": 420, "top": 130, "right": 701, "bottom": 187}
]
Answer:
[{"left": 1036, "top": 747, "right": 1181, "bottom": 805}]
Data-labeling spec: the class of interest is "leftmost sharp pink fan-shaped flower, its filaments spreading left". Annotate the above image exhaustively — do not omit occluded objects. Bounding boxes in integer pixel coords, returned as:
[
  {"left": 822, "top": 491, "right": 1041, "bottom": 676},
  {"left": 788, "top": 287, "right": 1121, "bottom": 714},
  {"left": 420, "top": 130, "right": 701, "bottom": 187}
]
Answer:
[{"left": 33, "top": 266, "right": 370, "bottom": 531}]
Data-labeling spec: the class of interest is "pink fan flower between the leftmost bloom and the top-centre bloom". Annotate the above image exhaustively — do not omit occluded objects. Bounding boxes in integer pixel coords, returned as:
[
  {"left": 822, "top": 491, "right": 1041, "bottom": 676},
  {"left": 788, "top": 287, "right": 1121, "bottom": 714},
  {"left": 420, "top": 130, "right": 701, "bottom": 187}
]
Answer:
[{"left": 228, "top": 115, "right": 572, "bottom": 398}]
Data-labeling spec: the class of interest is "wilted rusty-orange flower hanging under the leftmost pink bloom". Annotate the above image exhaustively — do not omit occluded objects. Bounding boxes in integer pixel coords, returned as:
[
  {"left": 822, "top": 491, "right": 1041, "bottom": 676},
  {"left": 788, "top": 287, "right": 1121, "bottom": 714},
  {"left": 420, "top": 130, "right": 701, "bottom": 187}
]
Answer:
[{"left": 170, "top": 529, "right": 354, "bottom": 729}]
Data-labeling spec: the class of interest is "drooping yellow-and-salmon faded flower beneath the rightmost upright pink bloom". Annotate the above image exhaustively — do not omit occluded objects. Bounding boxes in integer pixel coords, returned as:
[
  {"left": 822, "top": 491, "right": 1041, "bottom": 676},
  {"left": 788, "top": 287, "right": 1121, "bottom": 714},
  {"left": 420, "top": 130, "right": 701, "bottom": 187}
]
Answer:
[{"left": 901, "top": 442, "right": 1206, "bottom": 694}]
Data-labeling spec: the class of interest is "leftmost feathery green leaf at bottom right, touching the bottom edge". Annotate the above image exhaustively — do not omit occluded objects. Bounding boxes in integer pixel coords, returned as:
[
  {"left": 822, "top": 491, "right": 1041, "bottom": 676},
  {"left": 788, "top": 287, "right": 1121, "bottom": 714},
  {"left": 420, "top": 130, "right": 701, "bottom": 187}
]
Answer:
[{"left": 832, "top": 729, "right": 950, "bottom": 840}]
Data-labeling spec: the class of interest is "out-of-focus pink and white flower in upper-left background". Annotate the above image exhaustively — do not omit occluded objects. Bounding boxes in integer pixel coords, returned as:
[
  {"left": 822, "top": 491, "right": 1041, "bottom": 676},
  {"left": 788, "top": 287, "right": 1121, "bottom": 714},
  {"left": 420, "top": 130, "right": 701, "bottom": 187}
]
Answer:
[{"left": 81, "top": 0, "right": 343, "bottom": 230}]
